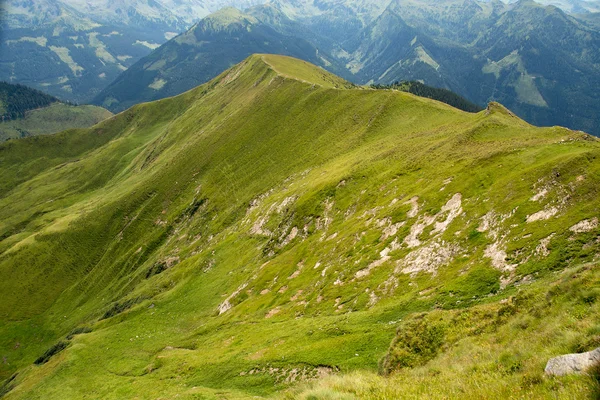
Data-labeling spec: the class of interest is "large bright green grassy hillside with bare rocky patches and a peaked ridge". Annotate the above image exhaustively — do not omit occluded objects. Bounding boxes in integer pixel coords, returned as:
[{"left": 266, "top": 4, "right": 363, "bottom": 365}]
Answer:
[{"left": 0, "top": 55, "right": 600, "bottom": 400}]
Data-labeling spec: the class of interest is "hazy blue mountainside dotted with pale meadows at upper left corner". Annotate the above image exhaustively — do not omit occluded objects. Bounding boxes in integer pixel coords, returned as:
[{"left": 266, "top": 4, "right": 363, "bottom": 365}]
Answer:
[{"left": 0, "top": 0, "right": 177, "bottom": 102}]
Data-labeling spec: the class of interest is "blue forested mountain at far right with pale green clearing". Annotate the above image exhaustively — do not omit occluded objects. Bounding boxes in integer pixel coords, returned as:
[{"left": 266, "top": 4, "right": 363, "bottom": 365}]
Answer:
[{"left": 475, "top": 1, "right": 600, "bottom": 134}]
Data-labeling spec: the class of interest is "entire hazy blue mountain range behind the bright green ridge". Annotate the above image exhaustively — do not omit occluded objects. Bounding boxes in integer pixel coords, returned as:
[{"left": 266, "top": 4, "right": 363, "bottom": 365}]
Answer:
[{"left": 0, "top": 0, "right": 600, "bottom": 135}]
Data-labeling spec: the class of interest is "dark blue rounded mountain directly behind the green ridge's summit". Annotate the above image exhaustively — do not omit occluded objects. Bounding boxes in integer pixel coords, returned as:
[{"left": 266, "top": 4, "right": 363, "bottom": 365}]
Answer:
[{"left": 94, "top": 8, "right": 346, "bottom": 111}]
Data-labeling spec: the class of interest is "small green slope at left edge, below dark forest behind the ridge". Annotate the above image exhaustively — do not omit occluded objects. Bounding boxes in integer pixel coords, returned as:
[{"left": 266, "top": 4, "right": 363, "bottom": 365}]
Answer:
[{"left": 0, "top": 103, "right": 112, "bottom": 141}]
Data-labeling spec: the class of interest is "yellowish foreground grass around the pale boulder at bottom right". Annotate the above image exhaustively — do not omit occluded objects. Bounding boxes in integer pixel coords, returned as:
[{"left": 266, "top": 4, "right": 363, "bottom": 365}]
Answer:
[{"left": 281, "top": 265, "right": 600, "bottom": 399}]
